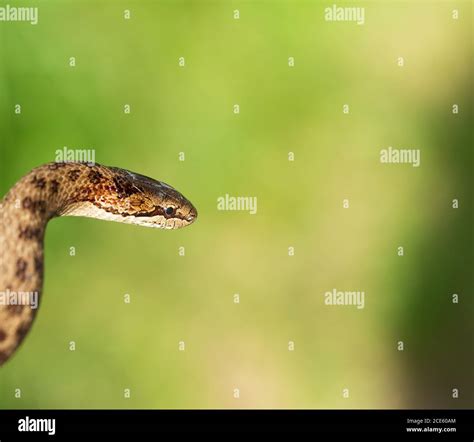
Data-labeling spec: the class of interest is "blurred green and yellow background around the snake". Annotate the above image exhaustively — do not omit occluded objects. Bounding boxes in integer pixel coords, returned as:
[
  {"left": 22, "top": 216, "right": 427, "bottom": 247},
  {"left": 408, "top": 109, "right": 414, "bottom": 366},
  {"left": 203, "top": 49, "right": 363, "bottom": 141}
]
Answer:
[{"left": 0, "top": 0, "right": 473, "bottom": 408}]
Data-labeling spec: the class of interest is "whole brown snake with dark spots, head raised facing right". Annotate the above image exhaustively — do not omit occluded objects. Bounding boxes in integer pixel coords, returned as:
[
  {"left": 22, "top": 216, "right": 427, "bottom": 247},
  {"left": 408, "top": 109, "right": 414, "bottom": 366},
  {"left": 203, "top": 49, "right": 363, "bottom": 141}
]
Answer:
[{"left": 0, "top": 162, "right": 197, "bottom": 366}]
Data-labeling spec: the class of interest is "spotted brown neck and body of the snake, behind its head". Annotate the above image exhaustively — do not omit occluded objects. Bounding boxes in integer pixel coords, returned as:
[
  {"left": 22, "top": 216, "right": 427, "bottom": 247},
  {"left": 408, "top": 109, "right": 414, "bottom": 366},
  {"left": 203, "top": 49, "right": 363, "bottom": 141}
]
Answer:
[{"left": 0, "top": 163, "right": 99, "bottom": 365}]
